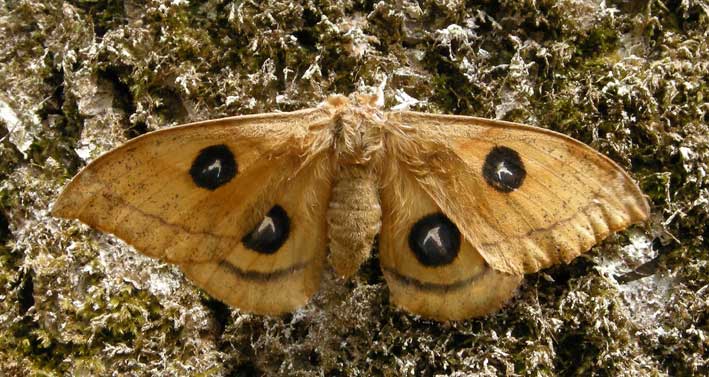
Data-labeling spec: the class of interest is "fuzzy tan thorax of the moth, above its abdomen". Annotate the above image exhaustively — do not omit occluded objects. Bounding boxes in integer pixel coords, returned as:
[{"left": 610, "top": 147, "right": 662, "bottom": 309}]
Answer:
[{"left": 325, "top": 95, "right": 385, "bottom": 165}]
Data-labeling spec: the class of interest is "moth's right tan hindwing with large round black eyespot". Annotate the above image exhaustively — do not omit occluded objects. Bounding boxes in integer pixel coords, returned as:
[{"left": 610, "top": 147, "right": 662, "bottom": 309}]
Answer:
[{"left": 379, "top": 161, "right": 522, "bottom": 320}]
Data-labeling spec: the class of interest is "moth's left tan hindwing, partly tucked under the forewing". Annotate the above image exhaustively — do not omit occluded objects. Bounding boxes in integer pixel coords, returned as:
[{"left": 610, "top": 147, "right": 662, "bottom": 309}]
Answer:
[{"left": 181, "top": 153, "right": 330, "bottom": 314}]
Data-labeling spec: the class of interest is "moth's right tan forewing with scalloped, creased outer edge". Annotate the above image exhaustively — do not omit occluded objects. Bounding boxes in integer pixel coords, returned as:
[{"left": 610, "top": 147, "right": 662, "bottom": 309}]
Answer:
[{"left": 388, "top": 112, "right": 649, "bottom": 274}]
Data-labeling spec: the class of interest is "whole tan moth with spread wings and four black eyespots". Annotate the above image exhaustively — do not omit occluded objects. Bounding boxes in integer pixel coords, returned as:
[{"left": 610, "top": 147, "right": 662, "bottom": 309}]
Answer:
[{"left": 53, "top": 95, "right": 649, "bottom": 321}]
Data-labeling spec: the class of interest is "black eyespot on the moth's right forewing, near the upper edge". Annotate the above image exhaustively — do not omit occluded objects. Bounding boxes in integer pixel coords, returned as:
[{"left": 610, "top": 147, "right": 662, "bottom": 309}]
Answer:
[{"left": 483, "top": 146, "right": 527, "bottom": 193}]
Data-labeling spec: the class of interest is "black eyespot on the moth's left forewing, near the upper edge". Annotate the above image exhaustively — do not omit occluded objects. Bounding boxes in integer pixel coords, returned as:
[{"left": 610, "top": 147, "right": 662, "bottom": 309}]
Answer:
[{"left": 190, "top": 144, "right": 238, "bottom": 190}]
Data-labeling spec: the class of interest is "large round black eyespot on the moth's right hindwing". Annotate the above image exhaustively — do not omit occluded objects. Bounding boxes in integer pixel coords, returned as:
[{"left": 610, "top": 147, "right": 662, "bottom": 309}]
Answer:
[{"left": 409, "top": 213, "right": 460, "bottom": 267}]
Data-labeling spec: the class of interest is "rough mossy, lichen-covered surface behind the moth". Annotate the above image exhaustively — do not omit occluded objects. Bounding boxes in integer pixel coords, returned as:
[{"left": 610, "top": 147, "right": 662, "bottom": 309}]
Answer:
[{"left": 0, "top": 0, "right": 709, "bottom": 376}]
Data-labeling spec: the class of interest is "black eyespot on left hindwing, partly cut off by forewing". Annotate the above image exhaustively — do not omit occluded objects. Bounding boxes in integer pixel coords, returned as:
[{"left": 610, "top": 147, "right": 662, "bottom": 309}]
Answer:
[{"left": 241, "top": 205, "right": 290, "bottom": 254}]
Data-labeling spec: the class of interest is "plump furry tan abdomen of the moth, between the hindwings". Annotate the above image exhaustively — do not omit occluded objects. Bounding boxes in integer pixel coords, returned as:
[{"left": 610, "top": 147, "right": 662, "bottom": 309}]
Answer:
[{"left": 327, "top": 165, "right": 382, "bottom": 278}]
